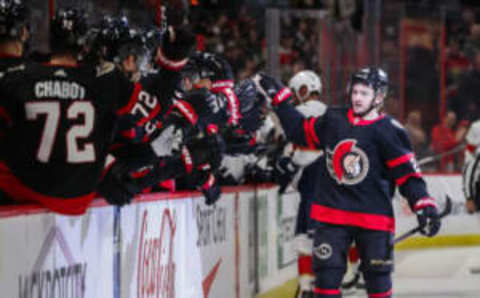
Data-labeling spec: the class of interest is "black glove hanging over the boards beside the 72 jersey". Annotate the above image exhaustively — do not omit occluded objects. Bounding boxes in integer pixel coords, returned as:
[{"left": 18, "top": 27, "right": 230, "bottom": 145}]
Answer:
[{"left": 98, "top": 161, "right": 142, "bottom": 206}]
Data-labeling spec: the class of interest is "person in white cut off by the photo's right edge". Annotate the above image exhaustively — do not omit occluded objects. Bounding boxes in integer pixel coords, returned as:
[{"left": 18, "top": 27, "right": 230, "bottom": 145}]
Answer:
[{"left": 462, "top": 120, "right": 480, "bottom": 213}]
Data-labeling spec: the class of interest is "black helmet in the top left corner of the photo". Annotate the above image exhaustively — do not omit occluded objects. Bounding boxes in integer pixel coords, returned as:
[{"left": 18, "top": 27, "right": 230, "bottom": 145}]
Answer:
[{"left": 0, "top": 0, "right": 28, "bottom": 39}]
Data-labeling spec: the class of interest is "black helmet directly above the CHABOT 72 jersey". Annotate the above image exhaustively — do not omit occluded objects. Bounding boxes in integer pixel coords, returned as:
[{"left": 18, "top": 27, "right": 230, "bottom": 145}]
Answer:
[{"left": 50, "top": 9, "right": 88, "bottom": 52}]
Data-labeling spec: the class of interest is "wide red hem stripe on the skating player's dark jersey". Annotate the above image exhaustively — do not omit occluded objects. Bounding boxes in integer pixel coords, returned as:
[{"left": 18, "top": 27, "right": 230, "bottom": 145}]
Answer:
[{"left": 310, "top": 204, "right": 395, "bottom": 233}]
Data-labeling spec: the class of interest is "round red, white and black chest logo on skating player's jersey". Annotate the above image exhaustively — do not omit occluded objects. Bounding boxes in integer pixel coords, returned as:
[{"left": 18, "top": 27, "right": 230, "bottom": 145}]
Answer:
[{"left": 326, "top": 139, "right": 369, "bottom": 185}]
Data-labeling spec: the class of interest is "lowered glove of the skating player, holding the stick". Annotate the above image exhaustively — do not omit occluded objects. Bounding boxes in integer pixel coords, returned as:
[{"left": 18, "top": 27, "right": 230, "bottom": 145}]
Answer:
[{"left": 414, "top": 198, "right": 441, "bottom": 237}]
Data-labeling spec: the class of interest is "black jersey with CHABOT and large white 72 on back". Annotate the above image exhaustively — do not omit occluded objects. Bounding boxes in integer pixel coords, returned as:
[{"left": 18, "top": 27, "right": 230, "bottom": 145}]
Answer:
[{"left": 0, "top": 62, "right": 141, "bottom": 214}]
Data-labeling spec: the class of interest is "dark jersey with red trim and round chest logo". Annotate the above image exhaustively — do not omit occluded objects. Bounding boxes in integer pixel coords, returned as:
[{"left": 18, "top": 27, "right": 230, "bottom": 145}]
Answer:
[{"left": 276, "top": 102, "right": 429, "bottom": 232}]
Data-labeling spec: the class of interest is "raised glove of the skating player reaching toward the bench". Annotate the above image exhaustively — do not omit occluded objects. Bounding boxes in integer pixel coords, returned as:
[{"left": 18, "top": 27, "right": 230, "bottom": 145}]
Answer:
[{"left": 252, "top": 73, "right": 292, "bottom": 106}]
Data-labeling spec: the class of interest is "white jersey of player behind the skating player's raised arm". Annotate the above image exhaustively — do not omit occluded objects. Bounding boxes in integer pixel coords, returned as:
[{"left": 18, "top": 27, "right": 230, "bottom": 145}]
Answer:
[{"left": 292, "top": 100, "right": 327, "bottom": 167}]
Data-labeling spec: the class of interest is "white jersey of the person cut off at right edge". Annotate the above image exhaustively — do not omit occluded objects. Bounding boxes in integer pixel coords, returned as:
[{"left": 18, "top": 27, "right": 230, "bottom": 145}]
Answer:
[{"left": 462, "top": 120, "right": 480, "bottom": 198}]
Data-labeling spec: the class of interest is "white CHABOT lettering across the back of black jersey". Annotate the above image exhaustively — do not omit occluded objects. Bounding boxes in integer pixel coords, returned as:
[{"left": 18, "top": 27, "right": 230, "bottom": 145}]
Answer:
[{"left": 35, "top": 81, "right": 85, "bottom": 99}]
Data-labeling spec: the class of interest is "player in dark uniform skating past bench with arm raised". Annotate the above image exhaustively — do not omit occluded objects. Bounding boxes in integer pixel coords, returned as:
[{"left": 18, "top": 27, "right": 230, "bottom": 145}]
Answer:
[{"left": 254, "top": 67, "right": 440, "bottom": 298}]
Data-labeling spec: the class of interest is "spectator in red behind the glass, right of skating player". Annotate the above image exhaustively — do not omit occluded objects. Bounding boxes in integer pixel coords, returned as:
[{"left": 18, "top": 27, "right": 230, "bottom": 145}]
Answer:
[{"left": 432, "top": 111, "right": 467, "bottom": 172}]
